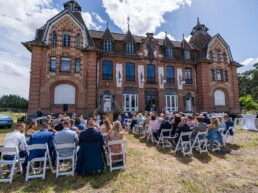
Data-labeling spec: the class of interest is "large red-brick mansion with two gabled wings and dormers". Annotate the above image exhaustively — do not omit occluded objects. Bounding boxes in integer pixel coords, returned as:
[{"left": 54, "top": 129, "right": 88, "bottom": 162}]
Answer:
[{"left": 22, "top": 0, "right": 241, "bottom": 114}]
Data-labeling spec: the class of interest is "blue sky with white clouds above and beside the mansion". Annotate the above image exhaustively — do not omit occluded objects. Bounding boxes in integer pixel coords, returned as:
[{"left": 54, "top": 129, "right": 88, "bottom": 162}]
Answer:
[{"left": 0, "top": 0, "right": 258, "bottom": 98}]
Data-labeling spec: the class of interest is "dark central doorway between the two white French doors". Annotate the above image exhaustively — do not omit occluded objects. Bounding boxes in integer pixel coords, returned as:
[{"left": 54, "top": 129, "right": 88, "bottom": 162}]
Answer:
[{"left": 145, "top": 89, "right": 158, "bottom": 112}]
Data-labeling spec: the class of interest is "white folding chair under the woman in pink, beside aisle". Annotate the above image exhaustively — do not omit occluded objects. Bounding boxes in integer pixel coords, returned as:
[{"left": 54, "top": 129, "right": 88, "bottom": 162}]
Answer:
[{"left": 108, "top": 140, "right": 125, "bottom": 172}]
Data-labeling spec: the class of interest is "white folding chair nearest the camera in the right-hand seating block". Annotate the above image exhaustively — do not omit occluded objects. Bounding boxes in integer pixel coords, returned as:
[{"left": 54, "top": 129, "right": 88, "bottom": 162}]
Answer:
[{"left": 175, "top": 131, "right": 193, "bottom": 156}]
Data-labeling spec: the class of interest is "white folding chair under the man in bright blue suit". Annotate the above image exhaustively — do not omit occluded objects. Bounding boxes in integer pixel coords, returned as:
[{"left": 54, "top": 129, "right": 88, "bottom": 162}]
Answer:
[{"left": 25, "top": 143, "right": 53, "bottom": 181}]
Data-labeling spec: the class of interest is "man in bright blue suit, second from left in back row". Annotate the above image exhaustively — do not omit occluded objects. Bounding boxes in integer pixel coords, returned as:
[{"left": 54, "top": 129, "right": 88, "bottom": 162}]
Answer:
[{"left": 28, "top": 122, "right": 55, "bottom": 160}]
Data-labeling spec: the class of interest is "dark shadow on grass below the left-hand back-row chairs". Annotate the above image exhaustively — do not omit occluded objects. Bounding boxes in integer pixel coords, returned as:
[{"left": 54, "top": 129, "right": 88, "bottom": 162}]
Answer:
[{"left": 0, "top": 167, "right": 121, "bottom": 192}]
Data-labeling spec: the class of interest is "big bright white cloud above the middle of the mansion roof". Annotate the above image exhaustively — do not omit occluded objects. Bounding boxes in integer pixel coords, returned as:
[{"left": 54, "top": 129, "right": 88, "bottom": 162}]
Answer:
[{"left": 103, "top": 0, "right": 192, "bottom": 35}]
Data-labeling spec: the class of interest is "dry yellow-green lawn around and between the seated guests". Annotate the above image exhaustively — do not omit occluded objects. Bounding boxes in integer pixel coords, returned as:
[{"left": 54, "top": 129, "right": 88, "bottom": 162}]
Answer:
[{"left": 0, "top": 126, "right": 258, "bottom": 193}]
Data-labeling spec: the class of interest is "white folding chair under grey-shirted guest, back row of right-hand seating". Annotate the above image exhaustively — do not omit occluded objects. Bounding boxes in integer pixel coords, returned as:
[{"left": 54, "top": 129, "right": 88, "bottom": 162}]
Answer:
[{"left": 191, "top": 131, "right": 208, "bottom": 153}]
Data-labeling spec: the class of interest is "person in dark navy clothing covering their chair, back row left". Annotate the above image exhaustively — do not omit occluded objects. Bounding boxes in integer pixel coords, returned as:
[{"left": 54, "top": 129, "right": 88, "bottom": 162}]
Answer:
[{"left": 76, "top": 119, "right": 107, "bottom": 176}]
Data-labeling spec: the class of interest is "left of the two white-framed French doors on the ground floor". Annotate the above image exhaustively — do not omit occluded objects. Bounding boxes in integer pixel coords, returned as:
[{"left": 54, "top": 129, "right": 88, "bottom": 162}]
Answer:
[{"left": 123, "top": 94, "right": 138, "bottom": 112}]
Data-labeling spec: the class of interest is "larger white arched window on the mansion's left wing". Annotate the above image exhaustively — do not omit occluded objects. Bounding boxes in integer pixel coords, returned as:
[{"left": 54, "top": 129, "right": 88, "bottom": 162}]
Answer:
[{"left": 54, "top": 84, "right": 75, "bottom": 105}]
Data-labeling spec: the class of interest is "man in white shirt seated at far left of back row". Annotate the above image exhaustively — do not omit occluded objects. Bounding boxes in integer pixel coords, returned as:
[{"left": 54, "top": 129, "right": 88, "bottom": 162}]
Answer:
[{"left": 3, "top": 123, "right": 27, "bottom": 167}]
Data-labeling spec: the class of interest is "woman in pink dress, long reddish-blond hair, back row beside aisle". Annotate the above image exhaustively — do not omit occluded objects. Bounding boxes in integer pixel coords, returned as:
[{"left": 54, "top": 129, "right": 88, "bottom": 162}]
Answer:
[{"left": 106, "top": 121, "right": 123, "bottom": 160}]
